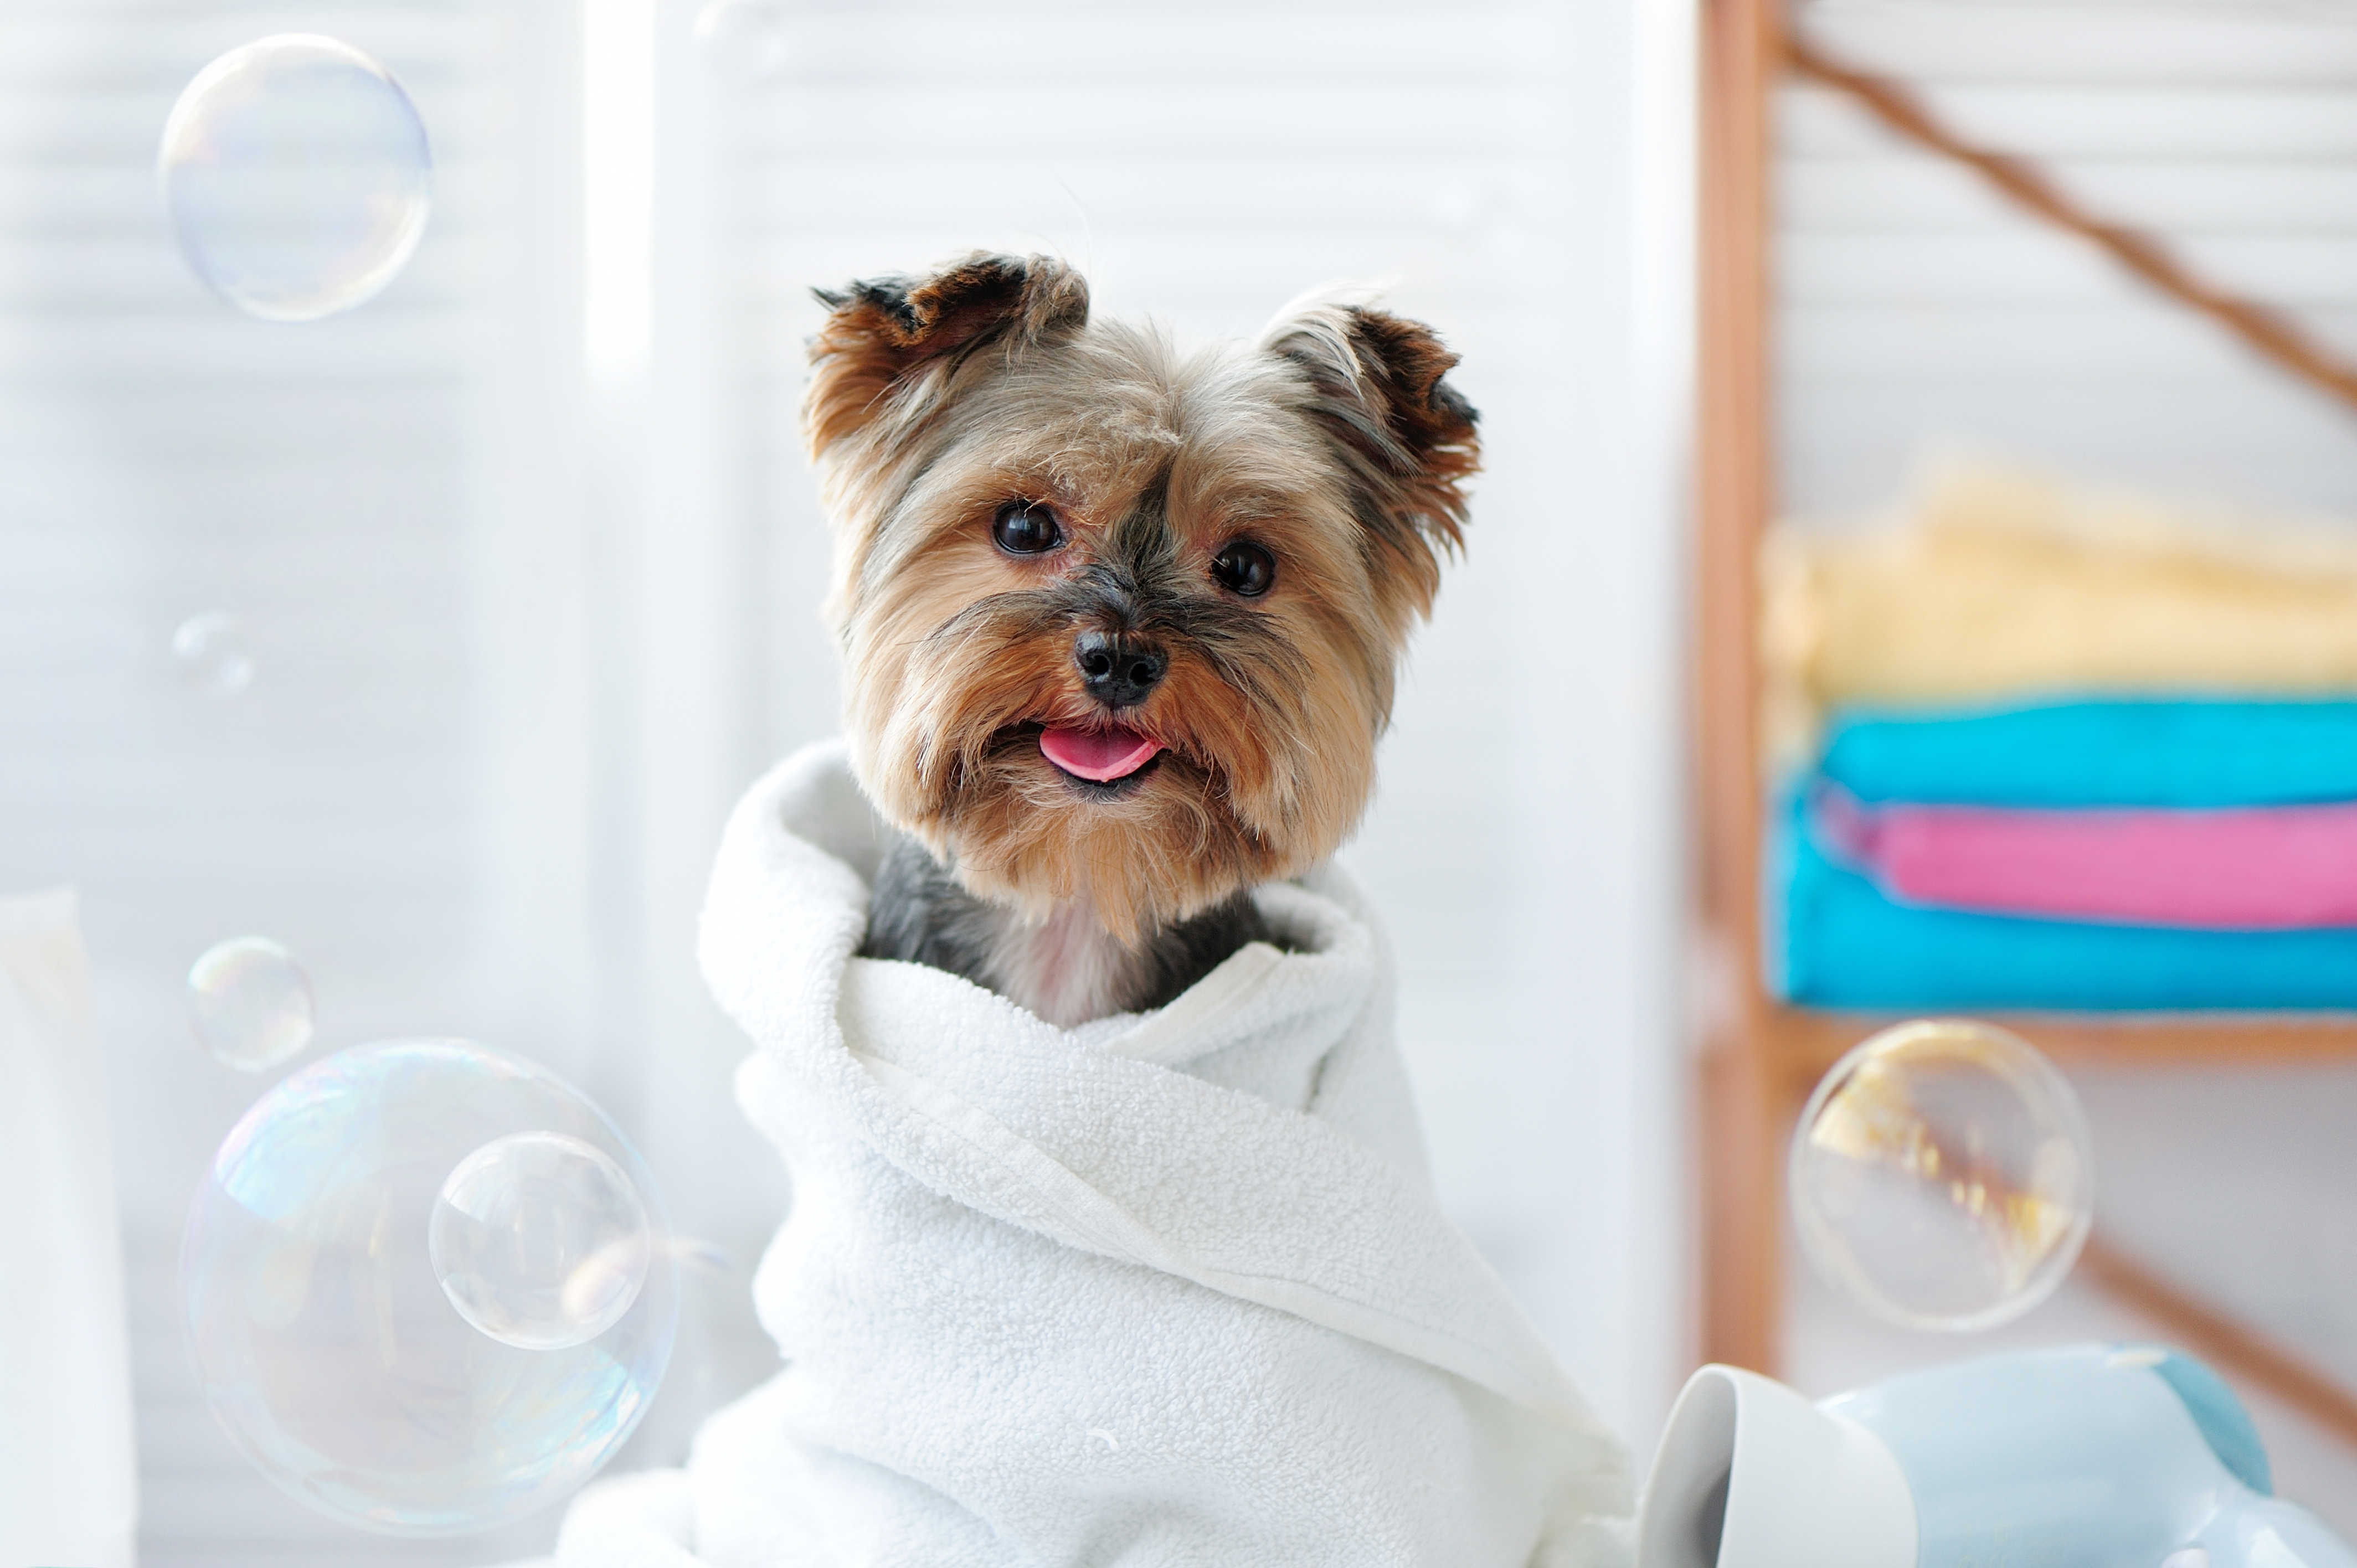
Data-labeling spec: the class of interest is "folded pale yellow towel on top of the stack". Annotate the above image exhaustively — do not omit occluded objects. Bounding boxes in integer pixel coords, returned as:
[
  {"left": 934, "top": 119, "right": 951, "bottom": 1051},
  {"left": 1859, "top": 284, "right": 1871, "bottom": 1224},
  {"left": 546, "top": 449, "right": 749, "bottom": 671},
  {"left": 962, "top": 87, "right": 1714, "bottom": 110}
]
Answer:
[{"left": 1761, "top": 462, "right": 2357, "bottom": 757}]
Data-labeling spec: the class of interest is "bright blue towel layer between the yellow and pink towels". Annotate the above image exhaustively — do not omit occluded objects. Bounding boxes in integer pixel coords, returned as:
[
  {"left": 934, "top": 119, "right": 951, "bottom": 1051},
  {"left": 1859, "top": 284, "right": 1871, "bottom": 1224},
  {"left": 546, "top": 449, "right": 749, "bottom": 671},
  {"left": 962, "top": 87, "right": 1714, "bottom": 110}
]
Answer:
[{"left": 1822, "top": 700, "right": 2357, "bottom": 806}]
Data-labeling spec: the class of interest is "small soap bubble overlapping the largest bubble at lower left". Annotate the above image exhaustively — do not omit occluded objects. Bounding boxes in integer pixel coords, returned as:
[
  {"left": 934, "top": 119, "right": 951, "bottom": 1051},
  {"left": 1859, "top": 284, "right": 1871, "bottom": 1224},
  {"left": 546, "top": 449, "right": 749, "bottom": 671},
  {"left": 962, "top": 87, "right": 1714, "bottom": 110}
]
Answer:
[{"left": 426, "top": 1132, "right": 653, "bottom": 1351}]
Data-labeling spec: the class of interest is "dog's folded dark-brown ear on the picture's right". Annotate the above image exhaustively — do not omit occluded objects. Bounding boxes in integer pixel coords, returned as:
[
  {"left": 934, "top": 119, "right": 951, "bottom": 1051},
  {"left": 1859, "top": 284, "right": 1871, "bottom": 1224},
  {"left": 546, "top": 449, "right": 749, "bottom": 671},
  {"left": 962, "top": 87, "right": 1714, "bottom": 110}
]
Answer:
[{"left": 1261, "top": 300, "right": 1480, "bottom": 616}]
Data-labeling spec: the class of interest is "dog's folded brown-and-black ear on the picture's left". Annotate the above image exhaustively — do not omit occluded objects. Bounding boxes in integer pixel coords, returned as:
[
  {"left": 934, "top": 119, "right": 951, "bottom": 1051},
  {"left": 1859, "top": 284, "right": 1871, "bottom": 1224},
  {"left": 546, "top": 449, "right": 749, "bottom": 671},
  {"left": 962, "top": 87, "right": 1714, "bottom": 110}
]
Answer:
[{"left": 801, "top": 250, "right": 1089, "bottom": 453}]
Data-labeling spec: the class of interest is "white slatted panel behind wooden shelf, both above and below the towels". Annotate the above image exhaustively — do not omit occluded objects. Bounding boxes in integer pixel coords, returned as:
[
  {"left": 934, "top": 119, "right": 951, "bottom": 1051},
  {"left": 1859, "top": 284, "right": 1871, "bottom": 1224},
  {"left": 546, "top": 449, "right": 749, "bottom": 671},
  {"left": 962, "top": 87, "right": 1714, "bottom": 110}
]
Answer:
[{"left": 1775, "top": 0, "right": 2357, "bottom": 1530}]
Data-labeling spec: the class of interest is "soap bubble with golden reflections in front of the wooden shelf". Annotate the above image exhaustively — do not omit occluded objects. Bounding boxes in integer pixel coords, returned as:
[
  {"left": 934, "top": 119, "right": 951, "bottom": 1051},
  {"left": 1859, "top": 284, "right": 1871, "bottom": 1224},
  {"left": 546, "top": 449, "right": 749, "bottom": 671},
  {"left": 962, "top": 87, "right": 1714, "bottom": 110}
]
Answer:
[{"left": 1792, "top": 1019, "right": 2096, "bottom": 1332}]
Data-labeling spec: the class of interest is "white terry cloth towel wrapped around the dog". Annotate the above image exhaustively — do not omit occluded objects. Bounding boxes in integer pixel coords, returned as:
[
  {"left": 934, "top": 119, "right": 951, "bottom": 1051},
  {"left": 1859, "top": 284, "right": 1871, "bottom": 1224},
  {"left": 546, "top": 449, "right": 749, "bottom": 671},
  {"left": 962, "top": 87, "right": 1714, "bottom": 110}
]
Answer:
[{"left": 559, "top": 745, "right": 1629, "bottom": 1568}]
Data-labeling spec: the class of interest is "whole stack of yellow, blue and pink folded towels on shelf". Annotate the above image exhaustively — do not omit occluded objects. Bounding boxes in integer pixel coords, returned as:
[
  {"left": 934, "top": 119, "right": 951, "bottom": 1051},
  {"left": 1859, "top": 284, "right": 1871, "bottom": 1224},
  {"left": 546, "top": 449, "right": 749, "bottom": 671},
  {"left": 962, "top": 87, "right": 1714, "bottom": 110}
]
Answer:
[{"left": 1763, "top": 465, "right": 2357, "bottom": 1009}]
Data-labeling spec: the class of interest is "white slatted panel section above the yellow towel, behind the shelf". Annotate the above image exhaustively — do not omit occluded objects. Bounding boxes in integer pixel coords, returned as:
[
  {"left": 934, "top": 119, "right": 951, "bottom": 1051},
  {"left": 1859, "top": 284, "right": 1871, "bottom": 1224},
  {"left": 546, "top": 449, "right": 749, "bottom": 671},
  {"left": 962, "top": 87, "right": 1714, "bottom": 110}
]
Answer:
[{"left": 1775, "top": 0, "right": 2357, "bottom": 517}]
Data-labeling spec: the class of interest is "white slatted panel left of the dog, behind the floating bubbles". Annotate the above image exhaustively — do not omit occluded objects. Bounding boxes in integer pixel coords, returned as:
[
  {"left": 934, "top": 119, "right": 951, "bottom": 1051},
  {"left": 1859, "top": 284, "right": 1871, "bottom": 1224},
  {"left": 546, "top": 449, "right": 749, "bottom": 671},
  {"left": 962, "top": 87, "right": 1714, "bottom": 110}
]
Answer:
[{"left": 0, "top": 0, "right": 582, "bottom": 1568}]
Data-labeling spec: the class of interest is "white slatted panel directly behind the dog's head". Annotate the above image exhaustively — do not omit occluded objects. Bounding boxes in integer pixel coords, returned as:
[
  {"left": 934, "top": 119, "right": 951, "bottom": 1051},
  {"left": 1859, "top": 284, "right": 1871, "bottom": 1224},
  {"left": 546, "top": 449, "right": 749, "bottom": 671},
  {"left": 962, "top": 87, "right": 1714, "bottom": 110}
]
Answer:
[{"left": 688, "top": 0, "right": 1683, "bottom": 1441}]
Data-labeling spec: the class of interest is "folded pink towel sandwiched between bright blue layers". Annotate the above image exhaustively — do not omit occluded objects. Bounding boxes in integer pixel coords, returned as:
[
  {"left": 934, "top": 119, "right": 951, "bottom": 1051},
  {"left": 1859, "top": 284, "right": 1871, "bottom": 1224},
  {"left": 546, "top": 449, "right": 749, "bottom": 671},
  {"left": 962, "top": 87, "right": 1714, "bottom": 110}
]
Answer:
[{"left": 1810, "top": 787, "right": 2357, "bottom": 931}]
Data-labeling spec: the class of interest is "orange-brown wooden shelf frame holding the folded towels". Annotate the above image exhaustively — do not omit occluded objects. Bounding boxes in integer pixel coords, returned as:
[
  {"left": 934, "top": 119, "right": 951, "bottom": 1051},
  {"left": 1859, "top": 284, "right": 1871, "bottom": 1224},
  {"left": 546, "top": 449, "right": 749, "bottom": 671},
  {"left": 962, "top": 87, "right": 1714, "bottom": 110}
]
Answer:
[{"left": 1692, "top": 0, "right": 2357, "bottom": 1405}]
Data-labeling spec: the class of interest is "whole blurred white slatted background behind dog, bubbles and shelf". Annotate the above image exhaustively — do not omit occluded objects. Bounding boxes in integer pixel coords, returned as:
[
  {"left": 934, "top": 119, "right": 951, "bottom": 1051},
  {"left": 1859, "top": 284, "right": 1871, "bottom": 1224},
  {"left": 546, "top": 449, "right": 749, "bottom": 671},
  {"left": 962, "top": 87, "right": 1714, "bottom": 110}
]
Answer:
[{"left": 23, "top": 0, "right": 2357, "bottom": 1568}]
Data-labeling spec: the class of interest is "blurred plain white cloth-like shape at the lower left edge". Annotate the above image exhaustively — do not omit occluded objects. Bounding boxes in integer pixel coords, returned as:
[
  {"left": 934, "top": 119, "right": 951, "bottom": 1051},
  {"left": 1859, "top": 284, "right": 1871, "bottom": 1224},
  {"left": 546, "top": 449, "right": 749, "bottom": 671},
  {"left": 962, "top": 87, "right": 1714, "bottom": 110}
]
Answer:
[{"left": 0, "top": 889, "right": 139, "bottom": 1568}]
